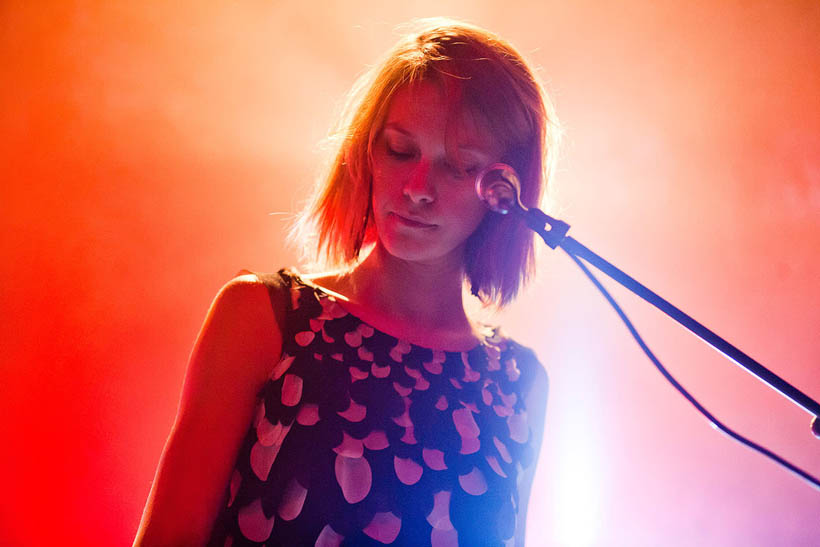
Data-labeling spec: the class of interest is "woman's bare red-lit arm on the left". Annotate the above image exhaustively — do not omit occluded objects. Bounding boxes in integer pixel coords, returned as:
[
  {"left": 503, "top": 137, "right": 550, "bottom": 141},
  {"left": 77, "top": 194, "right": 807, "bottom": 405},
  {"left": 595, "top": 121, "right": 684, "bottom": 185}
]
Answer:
[{"left": 134, "top": 275, "right": 282, "bottom": 546}]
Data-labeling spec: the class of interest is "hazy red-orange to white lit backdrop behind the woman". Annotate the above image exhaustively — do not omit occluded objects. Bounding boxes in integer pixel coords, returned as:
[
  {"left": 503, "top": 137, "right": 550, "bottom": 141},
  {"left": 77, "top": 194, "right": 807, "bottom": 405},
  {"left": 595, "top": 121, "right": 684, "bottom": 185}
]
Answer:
[{"left": 0, "top": 0, "right": 820, "bottom": 546}]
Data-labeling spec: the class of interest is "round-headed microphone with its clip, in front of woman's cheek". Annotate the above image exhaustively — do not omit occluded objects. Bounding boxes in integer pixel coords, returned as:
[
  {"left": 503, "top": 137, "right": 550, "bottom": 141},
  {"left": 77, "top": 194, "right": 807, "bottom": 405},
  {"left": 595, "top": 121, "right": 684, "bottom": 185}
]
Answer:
[{"left": 475, "top": 163, "right": 569, "bottom": 249}]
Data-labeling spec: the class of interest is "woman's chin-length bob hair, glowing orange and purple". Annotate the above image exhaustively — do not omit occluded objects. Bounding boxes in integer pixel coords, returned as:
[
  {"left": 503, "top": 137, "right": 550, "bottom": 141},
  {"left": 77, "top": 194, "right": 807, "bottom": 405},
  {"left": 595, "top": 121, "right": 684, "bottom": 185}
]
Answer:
[{"left": 291, "top": 18, "right": 559, "bottom": 307}]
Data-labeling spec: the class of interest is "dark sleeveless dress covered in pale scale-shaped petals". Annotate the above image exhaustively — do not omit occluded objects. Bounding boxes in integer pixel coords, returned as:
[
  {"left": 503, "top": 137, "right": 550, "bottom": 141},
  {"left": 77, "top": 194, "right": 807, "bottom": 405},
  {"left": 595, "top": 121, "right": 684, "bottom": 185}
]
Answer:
[{"left": 209, "top": 270, "right": 541, "bottom": 547}]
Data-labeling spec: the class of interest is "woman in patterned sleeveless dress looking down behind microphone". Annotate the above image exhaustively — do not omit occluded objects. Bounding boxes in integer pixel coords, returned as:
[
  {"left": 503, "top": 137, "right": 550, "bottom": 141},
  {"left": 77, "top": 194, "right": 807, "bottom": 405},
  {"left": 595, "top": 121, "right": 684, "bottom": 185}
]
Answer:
[{"left": 136, "top": 19, "right": 556, "bottom": 546}]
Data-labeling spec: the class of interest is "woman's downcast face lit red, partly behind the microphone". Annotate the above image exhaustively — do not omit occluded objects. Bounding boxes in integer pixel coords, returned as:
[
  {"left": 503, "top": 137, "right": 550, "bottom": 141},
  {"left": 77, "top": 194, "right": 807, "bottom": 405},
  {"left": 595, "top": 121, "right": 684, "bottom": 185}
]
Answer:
[{"left": 372, "top": 81, "right": 502, "bottom": 266}]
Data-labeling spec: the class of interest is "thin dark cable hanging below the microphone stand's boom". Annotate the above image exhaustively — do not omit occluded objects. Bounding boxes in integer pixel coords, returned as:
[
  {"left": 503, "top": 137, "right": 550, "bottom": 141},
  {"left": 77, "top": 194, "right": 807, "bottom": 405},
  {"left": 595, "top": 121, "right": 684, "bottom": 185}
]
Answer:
[{"left": 559, "top": 245, "right": 820, "bottom": 490}]
